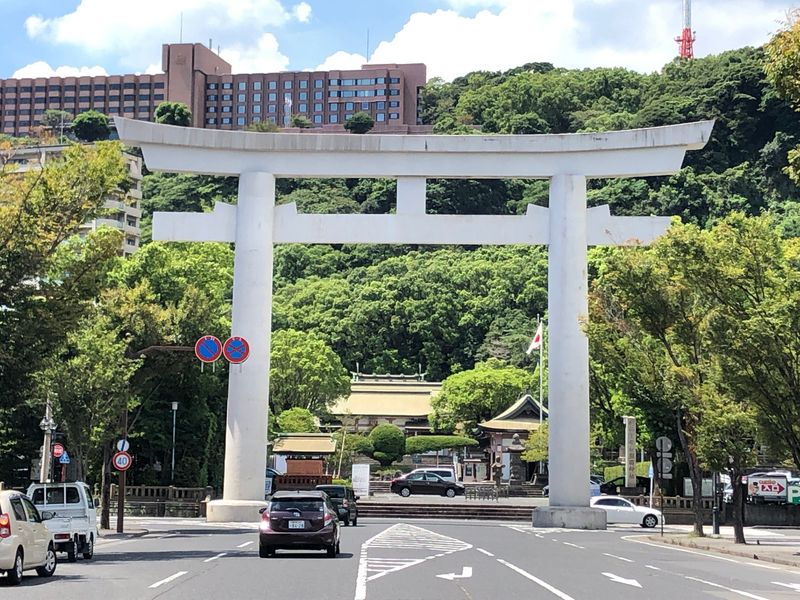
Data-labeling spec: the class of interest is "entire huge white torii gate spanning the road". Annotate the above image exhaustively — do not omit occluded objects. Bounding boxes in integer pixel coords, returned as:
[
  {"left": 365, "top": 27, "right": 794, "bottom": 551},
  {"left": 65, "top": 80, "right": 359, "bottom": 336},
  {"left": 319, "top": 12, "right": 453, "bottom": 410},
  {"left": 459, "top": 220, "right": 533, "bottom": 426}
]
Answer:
[{"left": 115, "top": 117, "right": 713, "bottom": 529}]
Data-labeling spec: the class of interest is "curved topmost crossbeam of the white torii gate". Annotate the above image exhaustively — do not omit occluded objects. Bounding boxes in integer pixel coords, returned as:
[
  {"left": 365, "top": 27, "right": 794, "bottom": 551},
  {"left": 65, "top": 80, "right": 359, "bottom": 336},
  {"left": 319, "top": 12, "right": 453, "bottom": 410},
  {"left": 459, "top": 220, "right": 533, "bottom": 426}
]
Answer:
[{"left": 114, "top": 117, "right": 714, "bottom": 179}]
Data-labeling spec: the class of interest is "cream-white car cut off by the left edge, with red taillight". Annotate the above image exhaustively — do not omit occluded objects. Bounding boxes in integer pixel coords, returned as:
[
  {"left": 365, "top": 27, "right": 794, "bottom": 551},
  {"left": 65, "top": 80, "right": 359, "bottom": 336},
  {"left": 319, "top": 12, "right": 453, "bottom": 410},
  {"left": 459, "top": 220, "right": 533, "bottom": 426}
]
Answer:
[{"left": 0, "top": 490, "right": 57, "bottom": 585}]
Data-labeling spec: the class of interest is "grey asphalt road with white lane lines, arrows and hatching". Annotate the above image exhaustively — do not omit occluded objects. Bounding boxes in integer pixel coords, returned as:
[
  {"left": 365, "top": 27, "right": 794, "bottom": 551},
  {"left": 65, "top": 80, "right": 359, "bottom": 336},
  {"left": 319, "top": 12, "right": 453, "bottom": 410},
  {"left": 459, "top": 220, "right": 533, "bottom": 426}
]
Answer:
[{"left": 0, "top": 519, "right": 800, "bottom": 600}]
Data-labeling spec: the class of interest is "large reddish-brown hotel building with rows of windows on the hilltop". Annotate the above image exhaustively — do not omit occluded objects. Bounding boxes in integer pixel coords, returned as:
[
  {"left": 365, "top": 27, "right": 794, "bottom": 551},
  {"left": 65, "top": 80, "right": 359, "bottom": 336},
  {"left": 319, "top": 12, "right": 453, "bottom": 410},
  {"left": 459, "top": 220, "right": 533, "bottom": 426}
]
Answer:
[{"left": 0, "top": 44, "right": 427, "bottom": 136}]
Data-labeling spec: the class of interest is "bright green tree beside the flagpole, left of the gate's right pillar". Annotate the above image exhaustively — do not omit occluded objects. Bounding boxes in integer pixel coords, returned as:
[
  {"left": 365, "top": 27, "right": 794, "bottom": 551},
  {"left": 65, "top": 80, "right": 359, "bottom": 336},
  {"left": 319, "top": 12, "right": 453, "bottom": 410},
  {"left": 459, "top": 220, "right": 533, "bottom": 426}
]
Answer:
[{"left": 430, "top": 359, "right": 531, "bottom": 431}]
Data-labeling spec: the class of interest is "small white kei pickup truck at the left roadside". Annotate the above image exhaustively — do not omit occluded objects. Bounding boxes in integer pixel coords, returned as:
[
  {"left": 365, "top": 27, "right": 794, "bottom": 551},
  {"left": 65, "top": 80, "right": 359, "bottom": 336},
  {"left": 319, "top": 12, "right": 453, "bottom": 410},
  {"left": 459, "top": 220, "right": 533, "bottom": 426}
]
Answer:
[{"left": 28, "top": 481, "right": 99, "bottom": 562}]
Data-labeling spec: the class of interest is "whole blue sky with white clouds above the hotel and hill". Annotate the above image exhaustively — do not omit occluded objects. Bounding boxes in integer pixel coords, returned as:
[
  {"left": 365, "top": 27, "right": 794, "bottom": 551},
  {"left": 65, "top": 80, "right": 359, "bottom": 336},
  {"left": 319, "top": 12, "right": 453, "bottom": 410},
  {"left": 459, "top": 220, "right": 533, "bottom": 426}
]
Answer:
[{"left": 0, "top": 0, "right": 792, "bottom": 80}]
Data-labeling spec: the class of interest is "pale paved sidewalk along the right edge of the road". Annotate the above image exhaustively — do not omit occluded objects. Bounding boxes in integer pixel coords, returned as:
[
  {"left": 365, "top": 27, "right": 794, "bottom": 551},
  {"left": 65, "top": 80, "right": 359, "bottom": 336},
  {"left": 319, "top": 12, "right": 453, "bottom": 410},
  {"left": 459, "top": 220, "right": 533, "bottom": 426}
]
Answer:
[{"left": 648, "top": 526, "right": 800, "bottom": 568}]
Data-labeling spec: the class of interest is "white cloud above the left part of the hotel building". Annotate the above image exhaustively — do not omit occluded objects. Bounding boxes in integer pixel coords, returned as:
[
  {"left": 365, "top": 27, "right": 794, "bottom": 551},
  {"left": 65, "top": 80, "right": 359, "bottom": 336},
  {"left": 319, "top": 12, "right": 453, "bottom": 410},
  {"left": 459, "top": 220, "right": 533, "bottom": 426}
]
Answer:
[{"left": 25, "top": 0, "right": 311, "bottom": 69}]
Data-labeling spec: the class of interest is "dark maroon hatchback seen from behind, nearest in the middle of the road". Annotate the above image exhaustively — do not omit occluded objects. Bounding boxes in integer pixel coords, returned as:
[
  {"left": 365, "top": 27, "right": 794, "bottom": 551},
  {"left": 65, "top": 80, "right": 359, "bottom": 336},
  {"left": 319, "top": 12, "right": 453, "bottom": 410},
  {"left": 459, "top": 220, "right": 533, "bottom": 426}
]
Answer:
[{"left": 258, "top": 490, "right": 339, "bottom": 558}]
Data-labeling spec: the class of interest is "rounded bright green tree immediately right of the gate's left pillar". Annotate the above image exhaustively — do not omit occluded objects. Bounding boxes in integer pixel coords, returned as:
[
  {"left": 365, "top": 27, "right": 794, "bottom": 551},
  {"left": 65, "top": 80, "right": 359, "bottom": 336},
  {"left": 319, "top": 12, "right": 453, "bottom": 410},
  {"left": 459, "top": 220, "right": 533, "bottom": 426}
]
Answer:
[{"left": 269, "top": 330, "right": 350, "bottom": 415}]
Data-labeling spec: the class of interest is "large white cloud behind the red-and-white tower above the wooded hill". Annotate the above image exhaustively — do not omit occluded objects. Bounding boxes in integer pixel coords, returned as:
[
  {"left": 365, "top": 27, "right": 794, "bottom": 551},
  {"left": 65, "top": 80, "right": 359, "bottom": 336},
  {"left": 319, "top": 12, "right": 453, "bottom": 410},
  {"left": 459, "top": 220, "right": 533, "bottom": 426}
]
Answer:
[{"left": 354, "top": 0, "right": 785, "bottom": 80}]
